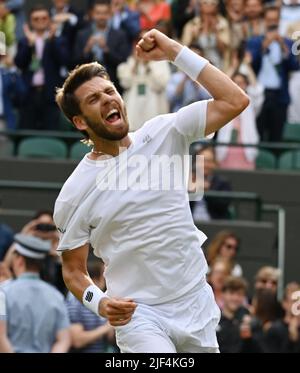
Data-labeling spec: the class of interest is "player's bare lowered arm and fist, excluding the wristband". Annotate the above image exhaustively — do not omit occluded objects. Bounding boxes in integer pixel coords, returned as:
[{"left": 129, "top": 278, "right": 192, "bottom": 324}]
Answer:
[{"left": 62, "top": 244, "right": 137, "bottom": 326}]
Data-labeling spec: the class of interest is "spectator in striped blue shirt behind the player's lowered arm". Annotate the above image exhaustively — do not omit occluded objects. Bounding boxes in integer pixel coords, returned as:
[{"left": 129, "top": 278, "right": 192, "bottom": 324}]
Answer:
[{"left": 67, "top": 260, "right": 114, "bottom": 353}]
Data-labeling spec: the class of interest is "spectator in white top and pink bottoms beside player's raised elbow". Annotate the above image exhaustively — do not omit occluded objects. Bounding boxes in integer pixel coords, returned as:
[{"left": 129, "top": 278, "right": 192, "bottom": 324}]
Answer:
[{"left": 216, "top": 67, "right": 263, "bottom": 170}]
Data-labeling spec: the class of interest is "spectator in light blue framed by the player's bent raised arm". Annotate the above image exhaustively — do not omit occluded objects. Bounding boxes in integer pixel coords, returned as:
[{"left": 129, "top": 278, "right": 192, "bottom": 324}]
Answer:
[{"left": 166, "top": 45, "right": 211, "bottom": 112}]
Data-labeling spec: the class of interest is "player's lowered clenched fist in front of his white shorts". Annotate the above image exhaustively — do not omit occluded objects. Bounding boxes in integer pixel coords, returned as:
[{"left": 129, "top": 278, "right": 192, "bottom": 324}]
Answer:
[{"left": 99, "top": 297, "right": 137, "bottom": 326}]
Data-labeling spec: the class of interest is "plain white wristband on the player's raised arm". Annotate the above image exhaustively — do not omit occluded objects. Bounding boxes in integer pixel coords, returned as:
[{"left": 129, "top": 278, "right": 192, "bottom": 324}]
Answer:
[{"left": 173, "top": 47, "right": 209, "bottom": 80}]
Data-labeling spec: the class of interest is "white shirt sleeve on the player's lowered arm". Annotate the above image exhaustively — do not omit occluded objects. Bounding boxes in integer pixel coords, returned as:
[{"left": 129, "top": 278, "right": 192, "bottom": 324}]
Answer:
[{"left": 54, "top": 201, "right": 90, "bottom": 254}]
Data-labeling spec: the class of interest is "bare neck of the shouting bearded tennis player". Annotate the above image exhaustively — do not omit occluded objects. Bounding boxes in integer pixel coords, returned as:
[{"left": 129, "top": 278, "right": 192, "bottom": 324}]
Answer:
[{"left": 90, "top": 135, "right": 131, "bottom": 159}]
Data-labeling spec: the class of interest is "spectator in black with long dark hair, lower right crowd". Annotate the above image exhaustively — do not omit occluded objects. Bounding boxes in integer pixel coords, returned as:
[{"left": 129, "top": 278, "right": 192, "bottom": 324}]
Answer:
[{"left": 241, "top": 289, "right": 290, "bottom": 353}]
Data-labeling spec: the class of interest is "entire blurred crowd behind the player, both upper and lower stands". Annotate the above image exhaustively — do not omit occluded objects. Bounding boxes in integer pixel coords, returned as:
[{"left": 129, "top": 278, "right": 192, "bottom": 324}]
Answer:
[{"left": 0, "top": 0, "right": 300, "bottom": 353}]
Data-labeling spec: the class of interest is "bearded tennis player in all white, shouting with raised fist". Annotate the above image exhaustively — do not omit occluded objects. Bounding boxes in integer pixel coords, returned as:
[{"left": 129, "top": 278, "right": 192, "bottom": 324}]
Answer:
[{"left": 54, "top": 30, "right": 249, "bottom": 353}]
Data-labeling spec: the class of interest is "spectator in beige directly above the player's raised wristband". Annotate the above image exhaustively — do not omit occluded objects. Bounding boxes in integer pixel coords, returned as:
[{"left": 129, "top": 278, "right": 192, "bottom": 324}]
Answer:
[{"left": 182, "top": 0, "right": 230, "bottom": 69}]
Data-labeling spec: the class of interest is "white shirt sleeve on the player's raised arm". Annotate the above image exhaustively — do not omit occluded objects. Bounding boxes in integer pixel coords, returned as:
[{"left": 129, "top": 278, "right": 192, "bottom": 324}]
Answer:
[{"left": 175, "top": 100, "right": 210, "bottom": 143}]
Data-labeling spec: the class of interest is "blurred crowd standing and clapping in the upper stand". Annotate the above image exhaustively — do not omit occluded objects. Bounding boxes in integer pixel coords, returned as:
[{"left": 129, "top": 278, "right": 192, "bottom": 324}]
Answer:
[{"left": 0, "top": 0, "right": 300, "bottom": 169}]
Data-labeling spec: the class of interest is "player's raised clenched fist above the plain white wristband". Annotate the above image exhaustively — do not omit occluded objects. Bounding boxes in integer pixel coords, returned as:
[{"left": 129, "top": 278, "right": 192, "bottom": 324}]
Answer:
[{"left": 136, "top": 29, "right": 182, "bottom": 61}]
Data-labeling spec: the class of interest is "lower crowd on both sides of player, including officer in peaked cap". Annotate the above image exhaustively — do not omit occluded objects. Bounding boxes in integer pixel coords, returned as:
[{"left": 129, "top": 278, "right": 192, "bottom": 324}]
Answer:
[{"left": 0, "top": 211, "right": 300, "bottom": 353}]
